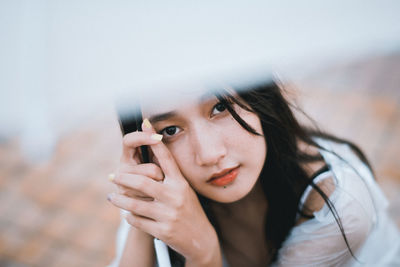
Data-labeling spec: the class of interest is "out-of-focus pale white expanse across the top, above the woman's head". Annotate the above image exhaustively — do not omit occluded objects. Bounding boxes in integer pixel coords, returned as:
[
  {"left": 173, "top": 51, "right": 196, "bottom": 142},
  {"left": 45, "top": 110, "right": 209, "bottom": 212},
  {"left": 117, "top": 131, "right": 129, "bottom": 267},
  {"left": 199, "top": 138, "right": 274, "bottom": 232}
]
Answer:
[{"left": 0, "top": 0, "right": 400, "bottom": 161}]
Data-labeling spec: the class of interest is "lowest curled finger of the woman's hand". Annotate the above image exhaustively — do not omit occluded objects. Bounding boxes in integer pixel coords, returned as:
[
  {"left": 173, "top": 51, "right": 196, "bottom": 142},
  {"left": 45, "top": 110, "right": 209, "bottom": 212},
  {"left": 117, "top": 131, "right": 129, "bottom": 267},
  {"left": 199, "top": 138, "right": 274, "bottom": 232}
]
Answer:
[{"left": 107, "top": 193, "right": 161, "bottom": 220}]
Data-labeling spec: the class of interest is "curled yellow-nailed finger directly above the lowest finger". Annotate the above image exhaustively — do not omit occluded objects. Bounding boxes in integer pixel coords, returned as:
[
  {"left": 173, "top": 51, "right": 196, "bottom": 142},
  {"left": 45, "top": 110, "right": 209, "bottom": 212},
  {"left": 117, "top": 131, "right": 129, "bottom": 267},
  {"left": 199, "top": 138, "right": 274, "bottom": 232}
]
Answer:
[{"left": 113, "top": 174, "right": 163, "bottom": 198}]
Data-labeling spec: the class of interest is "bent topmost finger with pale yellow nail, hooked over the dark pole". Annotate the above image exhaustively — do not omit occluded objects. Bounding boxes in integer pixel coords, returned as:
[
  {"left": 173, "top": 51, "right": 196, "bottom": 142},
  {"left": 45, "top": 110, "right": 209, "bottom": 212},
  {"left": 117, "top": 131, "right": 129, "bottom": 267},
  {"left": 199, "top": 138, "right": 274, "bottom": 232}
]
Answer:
[{"left": 121, "top": 132, "right": 165, "bottom": 164}]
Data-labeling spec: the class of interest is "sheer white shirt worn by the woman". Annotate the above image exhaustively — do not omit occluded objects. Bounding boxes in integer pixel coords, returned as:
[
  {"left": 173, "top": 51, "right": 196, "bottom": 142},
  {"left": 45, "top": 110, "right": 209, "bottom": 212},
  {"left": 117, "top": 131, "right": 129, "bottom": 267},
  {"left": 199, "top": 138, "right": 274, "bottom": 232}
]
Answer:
[{"left": 275, "top": 138, "right": 400, "bottom": 266}]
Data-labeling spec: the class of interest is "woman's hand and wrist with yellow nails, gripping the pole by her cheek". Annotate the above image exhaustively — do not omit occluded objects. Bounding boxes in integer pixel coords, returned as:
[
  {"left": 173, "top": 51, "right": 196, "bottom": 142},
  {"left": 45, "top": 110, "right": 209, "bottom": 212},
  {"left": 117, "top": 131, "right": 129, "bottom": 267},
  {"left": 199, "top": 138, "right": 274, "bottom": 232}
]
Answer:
[{"left": 110, "top": 121, "right": 221, "bottom": 266}]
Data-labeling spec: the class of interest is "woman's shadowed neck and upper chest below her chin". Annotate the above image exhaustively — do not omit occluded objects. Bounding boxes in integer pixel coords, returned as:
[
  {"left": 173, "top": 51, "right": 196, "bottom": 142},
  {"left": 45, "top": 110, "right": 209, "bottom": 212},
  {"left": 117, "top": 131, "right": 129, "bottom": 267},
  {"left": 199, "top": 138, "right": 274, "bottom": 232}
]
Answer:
[{"left": 210, "top": 182, "right": 269, "bottom": 266}]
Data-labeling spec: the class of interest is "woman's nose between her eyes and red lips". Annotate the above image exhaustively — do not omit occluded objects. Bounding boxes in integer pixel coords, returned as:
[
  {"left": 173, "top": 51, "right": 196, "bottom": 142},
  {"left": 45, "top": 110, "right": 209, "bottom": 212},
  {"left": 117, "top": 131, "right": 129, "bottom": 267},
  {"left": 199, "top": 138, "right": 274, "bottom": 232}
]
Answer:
[{"left": 193, "top": 126, "right": 227, "bottom": 166}]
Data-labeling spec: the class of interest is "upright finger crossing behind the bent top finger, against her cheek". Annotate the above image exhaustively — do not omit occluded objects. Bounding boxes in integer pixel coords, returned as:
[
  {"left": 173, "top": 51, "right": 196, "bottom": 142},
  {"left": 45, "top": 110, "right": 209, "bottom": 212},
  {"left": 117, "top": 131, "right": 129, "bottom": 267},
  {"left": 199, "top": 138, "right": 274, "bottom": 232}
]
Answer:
[{"left": 142, "top": 119, "right": 180, "bottom": 180}]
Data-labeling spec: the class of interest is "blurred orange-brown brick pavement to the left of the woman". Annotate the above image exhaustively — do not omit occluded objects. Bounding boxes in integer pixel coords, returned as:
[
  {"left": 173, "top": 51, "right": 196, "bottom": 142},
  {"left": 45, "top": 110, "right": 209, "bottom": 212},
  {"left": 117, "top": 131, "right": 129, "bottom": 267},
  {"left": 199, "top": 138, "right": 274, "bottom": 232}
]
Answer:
[{"left": 0, "top": 122, "right": 120, "bottom": 266}]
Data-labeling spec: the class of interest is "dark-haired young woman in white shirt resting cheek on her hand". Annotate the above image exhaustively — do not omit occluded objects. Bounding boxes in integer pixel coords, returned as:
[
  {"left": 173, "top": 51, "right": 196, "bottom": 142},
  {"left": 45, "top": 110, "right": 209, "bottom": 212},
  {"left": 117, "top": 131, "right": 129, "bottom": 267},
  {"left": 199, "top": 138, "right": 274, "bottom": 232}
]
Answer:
[{"left": 108, "top": 82, "right": 400, "bottom": 266}]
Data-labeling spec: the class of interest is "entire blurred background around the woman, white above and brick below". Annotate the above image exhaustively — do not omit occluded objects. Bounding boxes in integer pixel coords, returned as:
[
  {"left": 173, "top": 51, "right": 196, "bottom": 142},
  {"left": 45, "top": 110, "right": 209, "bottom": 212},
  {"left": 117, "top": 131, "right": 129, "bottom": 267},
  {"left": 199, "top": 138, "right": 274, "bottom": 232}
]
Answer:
[{"left": 0, "top": 0, "right": 400, "bottom": 266}]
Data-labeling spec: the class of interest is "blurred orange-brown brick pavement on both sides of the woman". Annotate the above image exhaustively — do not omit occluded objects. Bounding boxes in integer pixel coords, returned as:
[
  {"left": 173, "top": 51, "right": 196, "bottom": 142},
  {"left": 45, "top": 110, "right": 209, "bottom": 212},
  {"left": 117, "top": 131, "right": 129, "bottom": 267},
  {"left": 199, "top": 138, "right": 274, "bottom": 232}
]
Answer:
[{"left": 0, "top": 51, "right": 400, "bottom": 267}]
